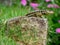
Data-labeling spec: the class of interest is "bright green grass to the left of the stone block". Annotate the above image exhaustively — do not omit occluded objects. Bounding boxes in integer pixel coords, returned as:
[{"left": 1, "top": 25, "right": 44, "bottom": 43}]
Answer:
[{"left": 0, "top": 5, "right": 29, "bottom": 45}]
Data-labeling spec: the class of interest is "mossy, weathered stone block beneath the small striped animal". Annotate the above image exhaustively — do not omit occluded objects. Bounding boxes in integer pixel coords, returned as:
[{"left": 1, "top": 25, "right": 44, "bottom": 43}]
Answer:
[{"left": 6, "top": 16, "right": 48, "bottom": 45}]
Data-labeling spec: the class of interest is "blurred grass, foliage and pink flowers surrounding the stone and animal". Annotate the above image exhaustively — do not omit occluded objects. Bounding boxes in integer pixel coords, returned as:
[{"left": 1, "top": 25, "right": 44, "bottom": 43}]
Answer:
[{"left": 0, "top": 0, "right": 60, "bottom": 45}]
